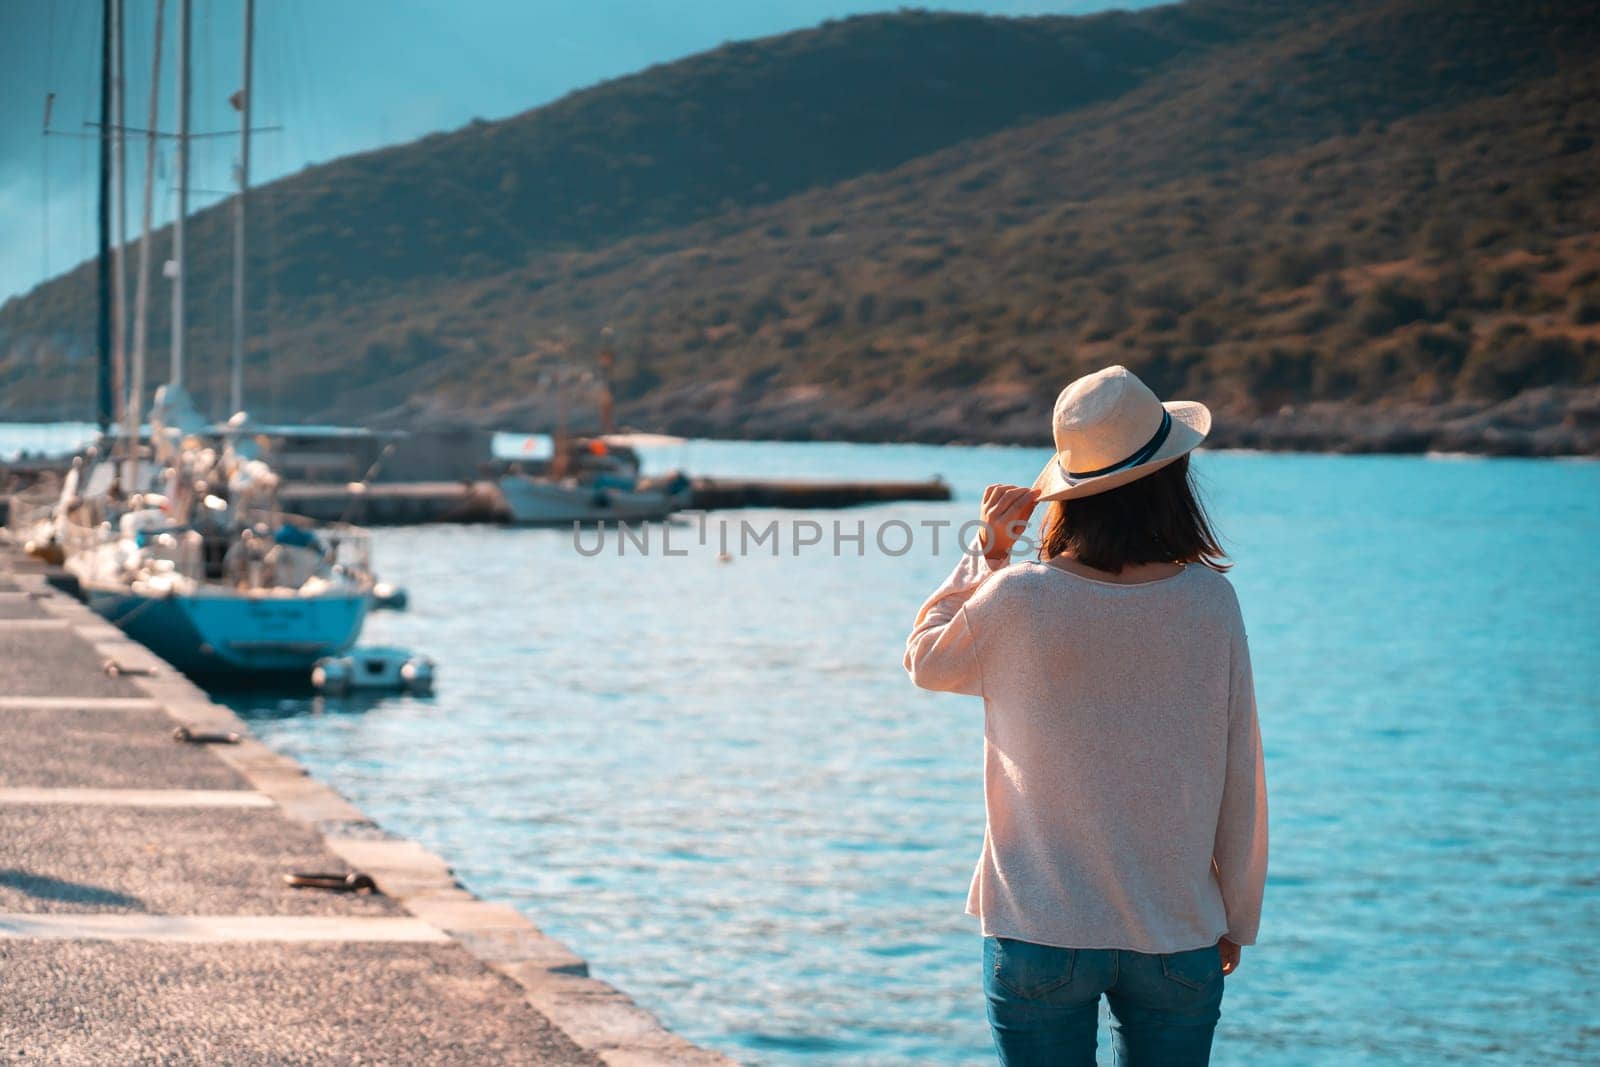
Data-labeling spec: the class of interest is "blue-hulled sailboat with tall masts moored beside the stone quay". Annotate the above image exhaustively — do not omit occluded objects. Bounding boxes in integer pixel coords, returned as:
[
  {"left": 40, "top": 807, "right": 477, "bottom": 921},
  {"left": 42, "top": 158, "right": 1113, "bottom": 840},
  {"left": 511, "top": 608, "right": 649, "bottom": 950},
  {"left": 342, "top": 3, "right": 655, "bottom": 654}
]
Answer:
[{"left": 56, "top": 0, "right": 374, "bottom": 681}]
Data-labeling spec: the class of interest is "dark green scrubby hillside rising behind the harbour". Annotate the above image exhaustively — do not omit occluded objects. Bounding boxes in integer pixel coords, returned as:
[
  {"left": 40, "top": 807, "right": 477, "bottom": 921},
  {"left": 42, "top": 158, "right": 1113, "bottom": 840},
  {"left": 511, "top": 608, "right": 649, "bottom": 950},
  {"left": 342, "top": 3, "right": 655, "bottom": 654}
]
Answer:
[{"left": 0, "top": 0, "right": 1600, "bottom": 451}]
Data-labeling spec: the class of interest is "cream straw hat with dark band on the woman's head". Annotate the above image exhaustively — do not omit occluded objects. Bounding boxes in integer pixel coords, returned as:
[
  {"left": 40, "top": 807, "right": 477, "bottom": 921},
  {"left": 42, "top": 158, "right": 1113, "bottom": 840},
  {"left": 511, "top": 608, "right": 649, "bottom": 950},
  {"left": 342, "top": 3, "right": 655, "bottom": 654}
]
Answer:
[{"left": 1034, "top": 365, "right": 1211, "bottom": 501}]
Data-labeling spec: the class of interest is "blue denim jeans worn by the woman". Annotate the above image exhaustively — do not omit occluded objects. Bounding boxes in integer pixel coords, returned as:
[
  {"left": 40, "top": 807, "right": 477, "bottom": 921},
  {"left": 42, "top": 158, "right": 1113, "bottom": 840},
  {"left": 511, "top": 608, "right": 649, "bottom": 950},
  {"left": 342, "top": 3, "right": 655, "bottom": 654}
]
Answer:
[{"left": 984, "top": 937, "right": 1222, "bottom": 1067}]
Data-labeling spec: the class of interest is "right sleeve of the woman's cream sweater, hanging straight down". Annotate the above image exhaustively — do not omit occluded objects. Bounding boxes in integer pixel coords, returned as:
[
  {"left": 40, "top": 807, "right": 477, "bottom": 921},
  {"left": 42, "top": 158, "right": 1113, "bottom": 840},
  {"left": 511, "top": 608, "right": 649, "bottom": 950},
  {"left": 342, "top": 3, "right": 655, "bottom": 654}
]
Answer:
[{"left": 1211, "top": 630, "right": 1267, "bottom": 945}]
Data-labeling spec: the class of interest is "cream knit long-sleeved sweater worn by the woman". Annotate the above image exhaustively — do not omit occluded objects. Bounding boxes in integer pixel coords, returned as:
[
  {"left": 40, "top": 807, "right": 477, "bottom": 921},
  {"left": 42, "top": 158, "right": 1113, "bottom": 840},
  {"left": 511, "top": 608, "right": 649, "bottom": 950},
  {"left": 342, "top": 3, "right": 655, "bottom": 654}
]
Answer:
[{"left": 906, "top": 555, "right": 1267, "bottom": 952}]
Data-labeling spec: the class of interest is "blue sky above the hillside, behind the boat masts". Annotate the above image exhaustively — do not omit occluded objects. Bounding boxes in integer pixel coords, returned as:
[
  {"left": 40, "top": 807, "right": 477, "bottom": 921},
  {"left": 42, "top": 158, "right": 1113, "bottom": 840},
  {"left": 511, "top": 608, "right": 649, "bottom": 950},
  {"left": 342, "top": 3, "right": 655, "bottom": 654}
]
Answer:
[{"left": 0, "top": 0, "right": 1150, "bottom": 301}]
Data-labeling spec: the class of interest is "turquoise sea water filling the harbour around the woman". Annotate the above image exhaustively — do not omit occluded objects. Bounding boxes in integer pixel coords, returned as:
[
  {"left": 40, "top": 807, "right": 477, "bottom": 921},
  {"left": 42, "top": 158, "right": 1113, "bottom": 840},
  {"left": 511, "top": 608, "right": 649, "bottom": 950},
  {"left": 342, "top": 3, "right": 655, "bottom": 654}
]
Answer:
[{"left": 9, "top": 425, "right": 1600, "bottom": 1065}]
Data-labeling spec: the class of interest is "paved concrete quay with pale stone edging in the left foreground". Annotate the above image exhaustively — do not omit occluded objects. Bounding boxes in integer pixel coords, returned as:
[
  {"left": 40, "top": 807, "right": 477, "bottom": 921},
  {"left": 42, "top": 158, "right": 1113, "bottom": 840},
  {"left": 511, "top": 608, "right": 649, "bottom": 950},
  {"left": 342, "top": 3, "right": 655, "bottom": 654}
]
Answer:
[{"left": 0, "top": 534, "right": 731, "bottom": 1067}]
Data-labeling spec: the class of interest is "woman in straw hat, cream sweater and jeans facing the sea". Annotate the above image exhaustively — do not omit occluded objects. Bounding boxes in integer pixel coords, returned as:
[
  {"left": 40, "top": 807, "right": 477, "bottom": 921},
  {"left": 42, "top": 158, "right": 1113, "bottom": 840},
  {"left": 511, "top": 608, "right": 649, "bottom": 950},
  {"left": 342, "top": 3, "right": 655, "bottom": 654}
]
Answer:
[{"left": 906, "top": 366, "right": 1267, "bottom": 1067}]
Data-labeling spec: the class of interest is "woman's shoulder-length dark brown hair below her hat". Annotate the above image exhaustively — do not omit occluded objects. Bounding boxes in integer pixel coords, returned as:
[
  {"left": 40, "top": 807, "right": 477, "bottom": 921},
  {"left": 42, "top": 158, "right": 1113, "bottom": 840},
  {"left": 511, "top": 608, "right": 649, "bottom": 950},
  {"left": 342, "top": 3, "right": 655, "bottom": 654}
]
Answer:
[{"left": 1038, "top": 453, "right": 1232, "bottom": 574}]
